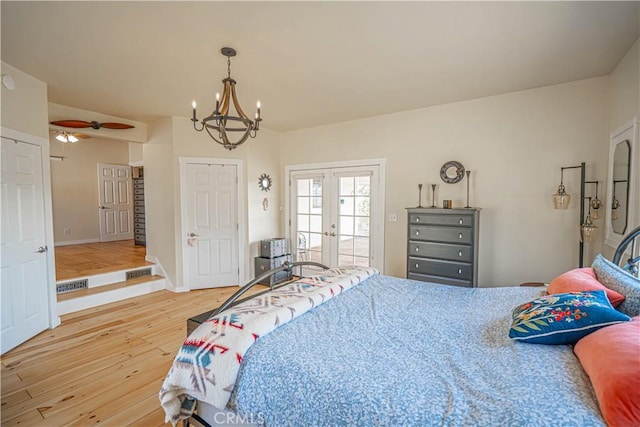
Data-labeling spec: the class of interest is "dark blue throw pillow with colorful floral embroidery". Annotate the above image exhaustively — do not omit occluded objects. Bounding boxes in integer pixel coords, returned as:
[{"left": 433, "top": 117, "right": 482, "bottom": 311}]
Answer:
[{"left": 509, "top": 291, "right": 631, "bottom": 344}]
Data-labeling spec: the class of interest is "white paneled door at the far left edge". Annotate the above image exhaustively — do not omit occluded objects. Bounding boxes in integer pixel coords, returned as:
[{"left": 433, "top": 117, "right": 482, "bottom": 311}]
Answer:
[{"left": 0, "top": 138, "right": 49, "bottom": 353}]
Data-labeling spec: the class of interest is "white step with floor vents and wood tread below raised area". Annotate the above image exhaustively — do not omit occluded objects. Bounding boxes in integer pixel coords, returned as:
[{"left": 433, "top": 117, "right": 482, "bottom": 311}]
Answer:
[{"left": 56, "top": 265, "right": 166, "bottom": 315}]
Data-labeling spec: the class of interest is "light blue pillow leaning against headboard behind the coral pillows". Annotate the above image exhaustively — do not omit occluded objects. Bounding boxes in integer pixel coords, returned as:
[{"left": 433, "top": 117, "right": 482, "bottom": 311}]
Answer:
[{"left": 591, "top": 254, "right": 640, "bottom": 317}]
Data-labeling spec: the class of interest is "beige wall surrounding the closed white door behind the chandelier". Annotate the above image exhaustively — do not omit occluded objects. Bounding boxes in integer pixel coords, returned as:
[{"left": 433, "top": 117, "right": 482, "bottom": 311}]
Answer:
[{"left": 143, "top": 117, "right": 281, "bottom": 289}]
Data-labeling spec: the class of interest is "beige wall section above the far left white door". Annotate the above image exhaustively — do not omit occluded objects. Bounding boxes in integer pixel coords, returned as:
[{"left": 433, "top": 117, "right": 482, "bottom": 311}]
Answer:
[{"left": 0, "top": 62, "right": 49, "bottom": 138}]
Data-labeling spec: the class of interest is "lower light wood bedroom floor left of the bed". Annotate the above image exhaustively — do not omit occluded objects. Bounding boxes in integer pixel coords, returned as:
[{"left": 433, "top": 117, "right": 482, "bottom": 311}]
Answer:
[{"left": 0, "top": 287, "right": 248, "bottom": 427}]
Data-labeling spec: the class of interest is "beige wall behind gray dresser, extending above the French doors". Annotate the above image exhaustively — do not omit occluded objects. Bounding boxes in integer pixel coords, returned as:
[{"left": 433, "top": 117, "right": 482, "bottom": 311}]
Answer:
[{"left": 281, "top": 77, "right": 609, "bottom": 286}]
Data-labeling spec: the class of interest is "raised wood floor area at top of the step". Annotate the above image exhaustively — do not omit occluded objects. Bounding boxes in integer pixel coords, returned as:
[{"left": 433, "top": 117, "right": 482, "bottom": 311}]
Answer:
[{"left": 55, "top": 240, "right": 152, "bottom": 281}]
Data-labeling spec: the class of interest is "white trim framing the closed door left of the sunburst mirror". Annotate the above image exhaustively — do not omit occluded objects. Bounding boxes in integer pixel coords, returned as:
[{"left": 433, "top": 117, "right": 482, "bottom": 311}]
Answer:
[{"left": 175, "top": 157, "right": 249, "bottom": 292}]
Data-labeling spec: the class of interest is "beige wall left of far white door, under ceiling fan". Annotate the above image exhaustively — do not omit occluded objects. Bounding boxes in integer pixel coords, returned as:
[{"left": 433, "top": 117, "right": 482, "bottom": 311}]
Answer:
[{"left": 49, "top": 136, "right": 129, "bottom": 244}]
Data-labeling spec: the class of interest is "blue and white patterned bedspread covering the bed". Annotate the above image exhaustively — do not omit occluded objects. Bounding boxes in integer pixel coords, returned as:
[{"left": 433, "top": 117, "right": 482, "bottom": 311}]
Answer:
[{"left": 230, "top": 276, "right": 603, "bottom": 426}]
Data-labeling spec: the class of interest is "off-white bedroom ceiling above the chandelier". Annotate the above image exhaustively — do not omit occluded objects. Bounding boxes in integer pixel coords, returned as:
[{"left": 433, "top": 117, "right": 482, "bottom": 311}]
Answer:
[{"left": 1, "top": 0, "right": 640, "bottom": 132}]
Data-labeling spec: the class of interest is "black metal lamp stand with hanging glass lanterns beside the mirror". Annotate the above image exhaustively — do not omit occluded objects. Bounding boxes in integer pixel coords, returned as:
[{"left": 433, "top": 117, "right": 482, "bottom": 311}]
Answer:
[{"left": 553, "top": 162, "right": 602, "bottom": 267}]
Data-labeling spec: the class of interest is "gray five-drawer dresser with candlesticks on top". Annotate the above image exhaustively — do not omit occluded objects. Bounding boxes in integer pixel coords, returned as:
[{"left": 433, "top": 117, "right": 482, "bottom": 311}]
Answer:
[{"left": 407, "top": 208, "right": 480, "bottom": 288}]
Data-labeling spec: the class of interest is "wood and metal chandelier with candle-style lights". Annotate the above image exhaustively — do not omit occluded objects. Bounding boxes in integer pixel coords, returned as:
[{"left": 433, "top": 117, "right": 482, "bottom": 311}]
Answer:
[{"left": 191, "top": 47, "right": 262, "bottom": 150}]
